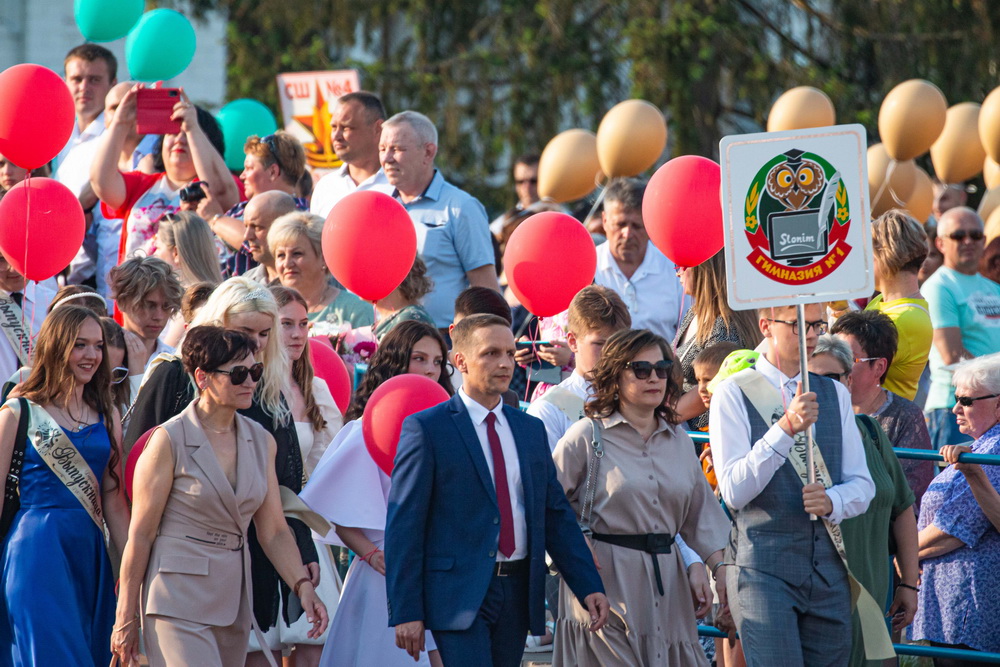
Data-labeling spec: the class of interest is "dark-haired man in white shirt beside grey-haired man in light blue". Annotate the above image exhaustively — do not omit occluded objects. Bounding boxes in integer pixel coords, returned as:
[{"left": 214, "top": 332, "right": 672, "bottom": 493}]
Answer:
[{"left": 309, "top": 91, "right": 393, "bottom": 218}]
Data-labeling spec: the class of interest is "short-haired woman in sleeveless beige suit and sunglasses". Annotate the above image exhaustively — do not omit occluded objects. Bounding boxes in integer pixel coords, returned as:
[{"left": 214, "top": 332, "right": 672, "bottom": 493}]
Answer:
[{"left": 111, "top": 326, "right": 328, "bottom": 667}]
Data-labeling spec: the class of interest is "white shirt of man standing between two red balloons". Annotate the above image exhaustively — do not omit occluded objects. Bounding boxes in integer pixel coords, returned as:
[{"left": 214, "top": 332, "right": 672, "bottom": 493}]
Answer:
[{"left": 594, "top": 241, "right": 691, "bottom": 342}]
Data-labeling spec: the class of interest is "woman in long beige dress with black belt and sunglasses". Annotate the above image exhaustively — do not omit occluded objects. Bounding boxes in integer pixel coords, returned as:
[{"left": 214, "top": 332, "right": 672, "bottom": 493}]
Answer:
[{"left": 553, "top": 330, "right": 729, "bottom": 667}]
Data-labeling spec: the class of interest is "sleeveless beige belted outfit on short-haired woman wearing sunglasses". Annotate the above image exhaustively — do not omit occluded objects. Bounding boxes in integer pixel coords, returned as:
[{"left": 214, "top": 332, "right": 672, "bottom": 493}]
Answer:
[{"left": 142, "top": 402, "right": 274, "bottom": 667}]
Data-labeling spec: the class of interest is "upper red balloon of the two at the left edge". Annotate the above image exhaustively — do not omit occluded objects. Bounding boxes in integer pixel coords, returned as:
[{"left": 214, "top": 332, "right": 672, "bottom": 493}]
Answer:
[{"left": 0, "top": 64, "right": 76, "bottom": 169}]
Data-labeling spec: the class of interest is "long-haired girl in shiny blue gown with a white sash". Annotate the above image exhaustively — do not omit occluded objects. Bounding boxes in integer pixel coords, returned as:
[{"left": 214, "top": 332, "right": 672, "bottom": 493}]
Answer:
[{"left": 0, "top": 305, "right": 129, "bottom": 667}]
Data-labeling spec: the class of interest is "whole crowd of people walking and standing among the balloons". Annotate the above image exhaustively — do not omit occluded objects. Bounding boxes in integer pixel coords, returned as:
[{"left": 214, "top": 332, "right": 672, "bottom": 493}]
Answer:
[{"left": 0, "top": 44, "right": 1000, "bottom": 667}]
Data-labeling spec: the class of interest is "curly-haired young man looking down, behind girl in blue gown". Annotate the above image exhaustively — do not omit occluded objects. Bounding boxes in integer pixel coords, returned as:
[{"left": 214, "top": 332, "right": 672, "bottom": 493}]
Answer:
[{"left": 108, "top": 257, "right": 184, "bottom": 366}]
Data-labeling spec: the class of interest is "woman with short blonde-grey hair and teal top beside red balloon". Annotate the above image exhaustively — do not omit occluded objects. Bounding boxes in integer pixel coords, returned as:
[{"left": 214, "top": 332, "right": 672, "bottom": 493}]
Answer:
[{"left": 267, "top": 211, "right": 375, "bottom": 333}]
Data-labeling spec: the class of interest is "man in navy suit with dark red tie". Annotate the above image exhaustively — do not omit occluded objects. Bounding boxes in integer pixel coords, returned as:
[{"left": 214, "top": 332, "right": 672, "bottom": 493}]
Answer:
[{"left": 385, "top": 315, "right": 608, "bottom": 667}]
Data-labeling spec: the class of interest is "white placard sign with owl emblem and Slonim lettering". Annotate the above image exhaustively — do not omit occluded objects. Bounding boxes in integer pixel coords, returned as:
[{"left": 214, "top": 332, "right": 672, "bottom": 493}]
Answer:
[{"left": 719, "top": 125, "right": 875, "bottom": 310}]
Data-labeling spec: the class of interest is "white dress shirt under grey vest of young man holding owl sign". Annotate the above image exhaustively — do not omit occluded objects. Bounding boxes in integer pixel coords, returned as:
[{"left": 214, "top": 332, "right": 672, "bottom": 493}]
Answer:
[{"left": 708, "top": 355, "right": 875, "bottom": 523}]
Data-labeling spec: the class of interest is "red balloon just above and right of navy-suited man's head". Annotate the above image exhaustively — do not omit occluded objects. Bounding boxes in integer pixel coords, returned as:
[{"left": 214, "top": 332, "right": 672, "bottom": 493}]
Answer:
[{"left": 503, "top": 211, "right": 597, "bottom": 317}]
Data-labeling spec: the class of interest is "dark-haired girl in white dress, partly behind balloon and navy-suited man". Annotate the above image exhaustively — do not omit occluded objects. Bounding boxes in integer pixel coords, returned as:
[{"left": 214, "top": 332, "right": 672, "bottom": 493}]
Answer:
[{"left": 301, "top": 320, "right": 454, "bottom": 667}]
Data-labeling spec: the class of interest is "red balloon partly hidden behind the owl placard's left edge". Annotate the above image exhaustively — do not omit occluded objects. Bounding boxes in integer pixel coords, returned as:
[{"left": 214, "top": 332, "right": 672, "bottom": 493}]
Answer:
[{"left": 642, "top": 155, "right": 724, "bottom": 267}]
